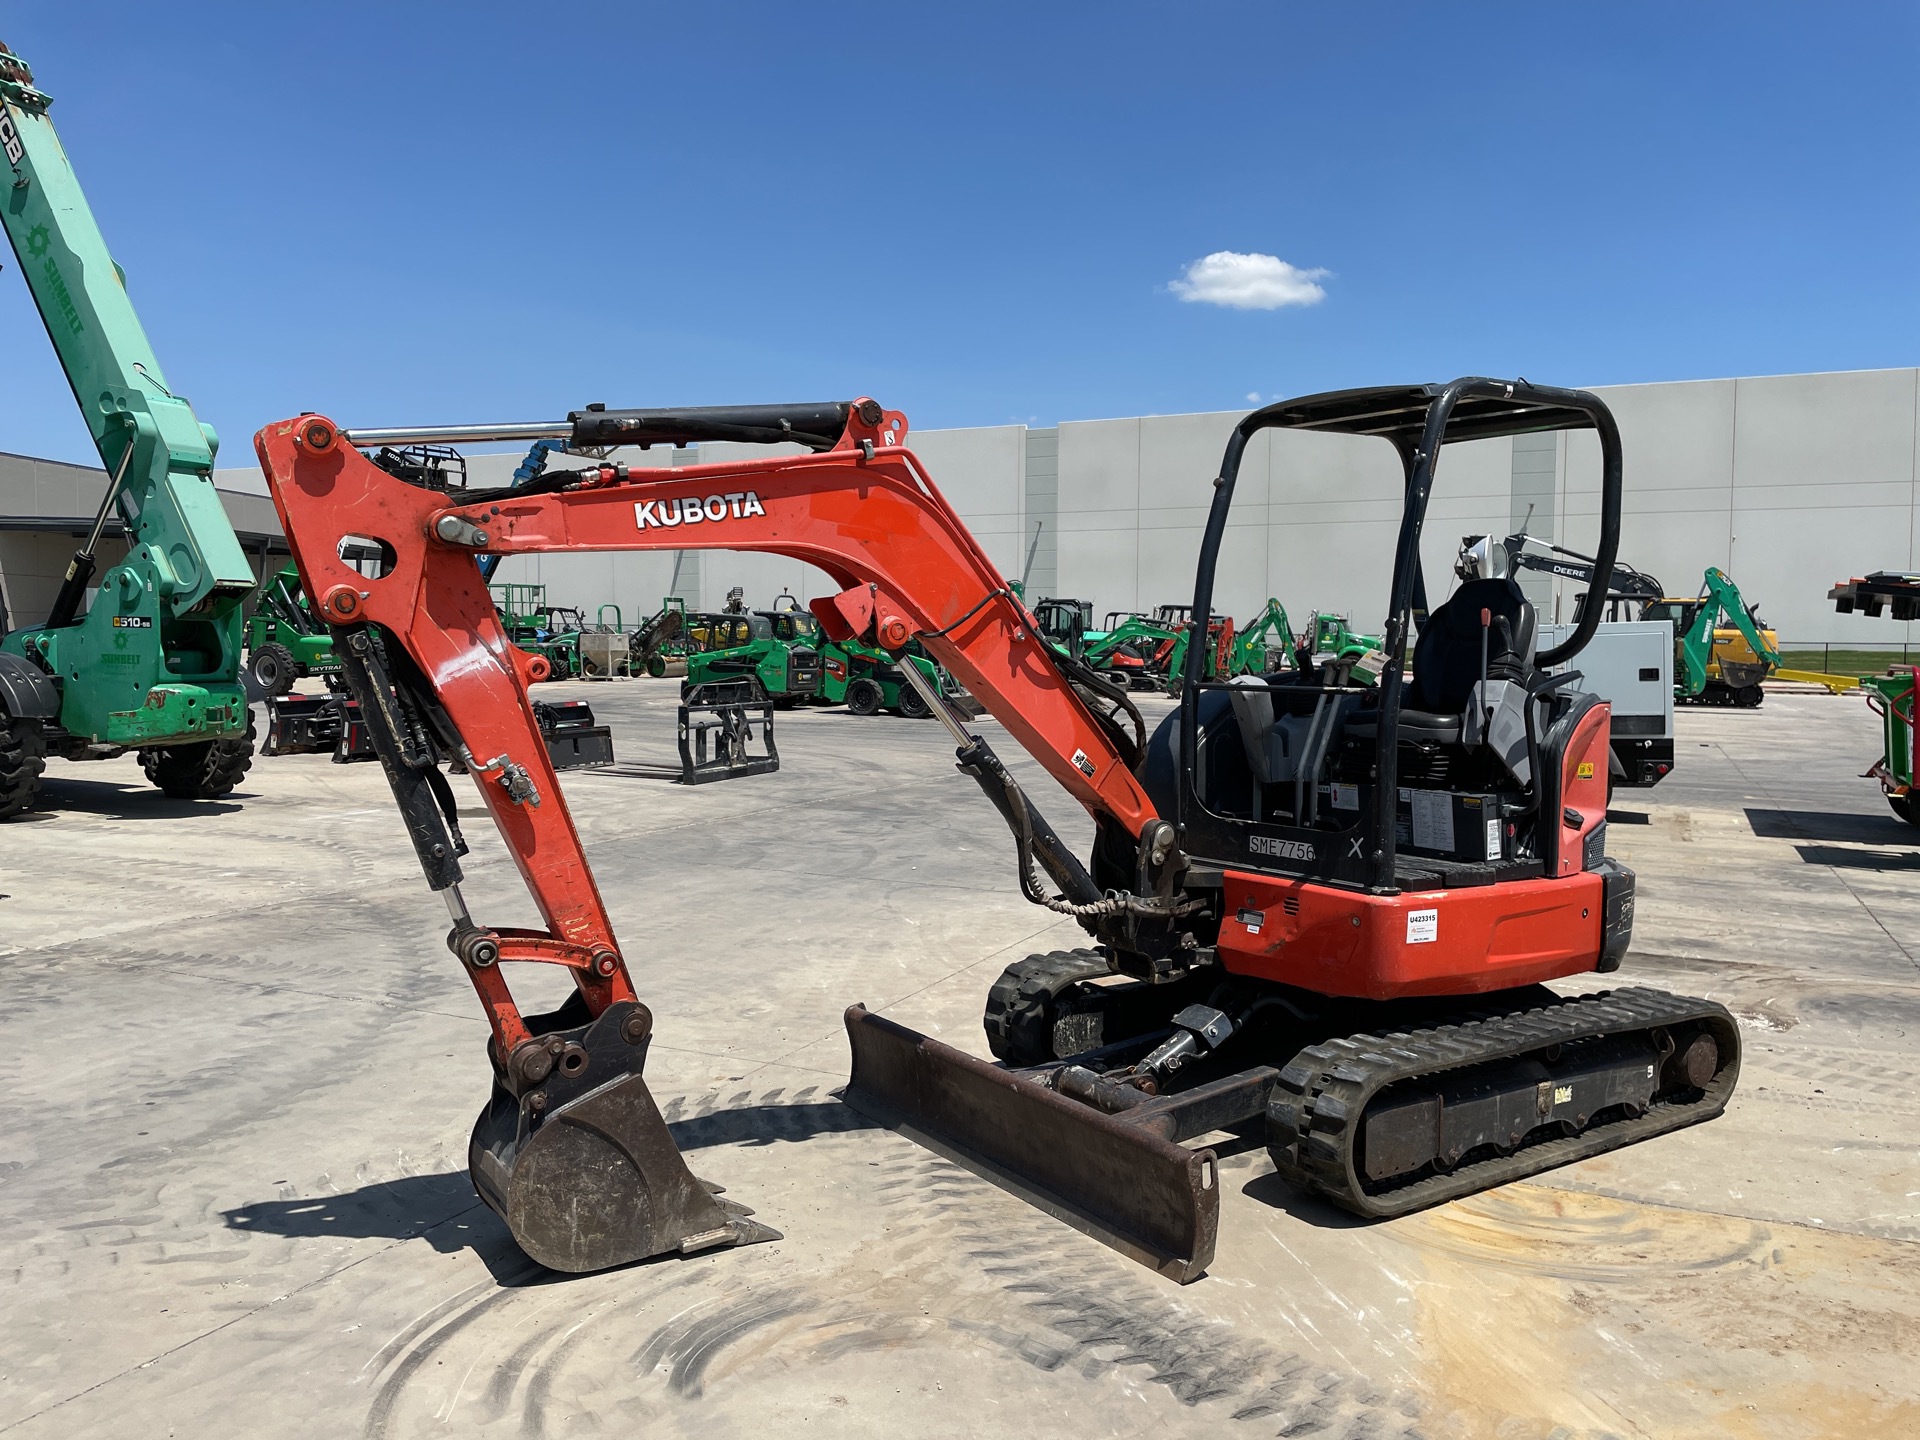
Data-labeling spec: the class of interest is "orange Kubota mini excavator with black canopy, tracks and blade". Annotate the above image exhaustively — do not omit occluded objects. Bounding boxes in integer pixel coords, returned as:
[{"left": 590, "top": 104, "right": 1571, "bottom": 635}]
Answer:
[{"left": 255, "top": 378, "right": 1740, "bottom": 1281}]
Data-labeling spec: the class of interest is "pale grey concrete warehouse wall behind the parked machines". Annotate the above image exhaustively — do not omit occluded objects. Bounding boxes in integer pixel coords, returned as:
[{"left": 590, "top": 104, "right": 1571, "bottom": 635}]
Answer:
[{"left": 176, "top": 369, "right": 1920, "bottom": 645}]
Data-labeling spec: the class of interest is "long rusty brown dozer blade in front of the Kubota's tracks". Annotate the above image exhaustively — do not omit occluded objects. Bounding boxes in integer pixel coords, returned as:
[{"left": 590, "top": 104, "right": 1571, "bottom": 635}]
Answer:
[{"left": 843, "top": 1004, "right": 1219, "bottom": 1284}]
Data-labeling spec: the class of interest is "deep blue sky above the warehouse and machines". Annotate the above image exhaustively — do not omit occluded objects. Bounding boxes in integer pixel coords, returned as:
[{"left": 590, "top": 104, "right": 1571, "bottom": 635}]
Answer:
[{"left": 0, "top": 0, "right": 1920, "bottom": 465}]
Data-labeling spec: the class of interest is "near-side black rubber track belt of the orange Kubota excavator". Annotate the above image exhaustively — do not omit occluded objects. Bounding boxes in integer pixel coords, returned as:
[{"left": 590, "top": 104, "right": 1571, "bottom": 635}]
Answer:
[{"left": 1267, "top": 989, "right": 1740, "bottom": 1219}]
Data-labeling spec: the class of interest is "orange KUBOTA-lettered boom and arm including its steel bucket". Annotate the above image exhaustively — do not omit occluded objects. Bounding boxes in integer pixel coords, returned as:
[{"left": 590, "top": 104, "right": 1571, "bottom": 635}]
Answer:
[{"left": 255, "top": 399, "right": 1185, "bottom": 1271}]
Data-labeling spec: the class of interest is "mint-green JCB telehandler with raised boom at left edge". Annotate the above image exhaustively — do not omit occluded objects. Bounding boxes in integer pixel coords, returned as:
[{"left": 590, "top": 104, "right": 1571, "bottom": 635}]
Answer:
[{"left": 0, "top": 46, "right": 253, "bottom": 820}]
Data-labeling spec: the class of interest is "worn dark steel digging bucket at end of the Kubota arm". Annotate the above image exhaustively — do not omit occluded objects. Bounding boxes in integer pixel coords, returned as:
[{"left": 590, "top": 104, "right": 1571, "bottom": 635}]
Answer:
[{"left": 467, "top": 1002, "right": 780, "bottom": 1275}]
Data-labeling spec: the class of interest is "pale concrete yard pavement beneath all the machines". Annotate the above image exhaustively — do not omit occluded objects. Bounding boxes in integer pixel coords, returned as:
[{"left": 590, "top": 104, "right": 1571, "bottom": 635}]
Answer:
[{"left": 0, "top": 682, "right": 1920, "bottom": 1440}]
